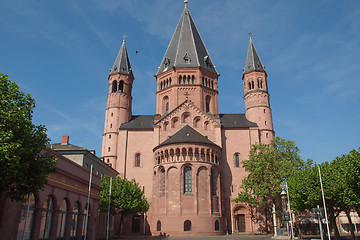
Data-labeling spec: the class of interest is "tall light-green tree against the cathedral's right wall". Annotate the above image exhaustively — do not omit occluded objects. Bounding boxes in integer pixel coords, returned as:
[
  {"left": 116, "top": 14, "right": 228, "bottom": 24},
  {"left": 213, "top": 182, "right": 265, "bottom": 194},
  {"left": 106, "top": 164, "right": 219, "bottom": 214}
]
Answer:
[{"left": 235, "top": 137, "right": 312, "bottom": 232}]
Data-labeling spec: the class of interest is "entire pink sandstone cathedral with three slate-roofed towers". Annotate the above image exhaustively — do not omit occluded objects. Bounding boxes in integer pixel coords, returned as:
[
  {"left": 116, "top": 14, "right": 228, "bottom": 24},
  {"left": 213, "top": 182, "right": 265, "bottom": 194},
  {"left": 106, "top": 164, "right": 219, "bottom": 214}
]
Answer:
[{"left": 102, "top": 0, "right": 274, "bottom": 235}]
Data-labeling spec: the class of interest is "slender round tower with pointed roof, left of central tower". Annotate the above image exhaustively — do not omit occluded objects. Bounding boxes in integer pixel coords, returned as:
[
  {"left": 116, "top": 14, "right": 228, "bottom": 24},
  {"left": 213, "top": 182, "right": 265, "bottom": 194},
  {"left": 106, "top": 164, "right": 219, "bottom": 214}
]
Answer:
[{"left": 101, "top": 39, "right": 134, "bottom": 167}]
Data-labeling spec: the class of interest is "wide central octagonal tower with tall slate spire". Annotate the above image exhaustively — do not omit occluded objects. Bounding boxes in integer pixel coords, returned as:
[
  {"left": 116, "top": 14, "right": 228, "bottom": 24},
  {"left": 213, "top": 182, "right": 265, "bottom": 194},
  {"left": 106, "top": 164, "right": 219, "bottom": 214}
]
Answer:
[{"left": 155, "top": 1, "right": 219, "bottom": 116}]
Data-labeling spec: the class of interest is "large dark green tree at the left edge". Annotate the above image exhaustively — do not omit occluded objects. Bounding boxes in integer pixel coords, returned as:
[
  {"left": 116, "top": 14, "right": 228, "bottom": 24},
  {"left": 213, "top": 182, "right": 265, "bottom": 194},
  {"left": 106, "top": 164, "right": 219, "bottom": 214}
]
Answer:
[{"left": 0, "top": 73, "right": 56, "bottom": 200}]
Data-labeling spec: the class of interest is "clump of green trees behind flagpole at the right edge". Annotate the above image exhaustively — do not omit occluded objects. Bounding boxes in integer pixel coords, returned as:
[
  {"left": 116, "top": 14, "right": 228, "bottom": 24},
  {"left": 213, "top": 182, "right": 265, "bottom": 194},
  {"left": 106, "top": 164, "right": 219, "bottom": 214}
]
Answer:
[{"left": 288, "top": 149, "right": 360, "bottom": 239}]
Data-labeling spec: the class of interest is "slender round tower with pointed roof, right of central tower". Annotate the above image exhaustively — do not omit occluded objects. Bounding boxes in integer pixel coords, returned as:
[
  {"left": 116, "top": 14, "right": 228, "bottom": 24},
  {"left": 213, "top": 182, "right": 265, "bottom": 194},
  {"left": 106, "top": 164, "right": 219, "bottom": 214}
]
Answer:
[{"left": 242, "top": 37, "right": 274, "bottom": 144}]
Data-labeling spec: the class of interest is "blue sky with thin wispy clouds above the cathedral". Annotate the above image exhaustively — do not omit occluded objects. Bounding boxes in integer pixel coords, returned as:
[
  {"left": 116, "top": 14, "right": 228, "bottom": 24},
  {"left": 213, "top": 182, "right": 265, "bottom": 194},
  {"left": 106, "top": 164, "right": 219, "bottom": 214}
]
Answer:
[{"left": 0, "top": 0, "right": 360, "bottom": 163}]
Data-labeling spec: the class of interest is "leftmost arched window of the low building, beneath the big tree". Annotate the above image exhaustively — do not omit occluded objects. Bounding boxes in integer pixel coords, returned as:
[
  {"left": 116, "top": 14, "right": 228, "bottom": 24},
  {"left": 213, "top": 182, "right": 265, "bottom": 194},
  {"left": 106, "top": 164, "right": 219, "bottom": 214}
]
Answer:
[{"left": 17, "top": 194, "right": 36, "bottom": 239}]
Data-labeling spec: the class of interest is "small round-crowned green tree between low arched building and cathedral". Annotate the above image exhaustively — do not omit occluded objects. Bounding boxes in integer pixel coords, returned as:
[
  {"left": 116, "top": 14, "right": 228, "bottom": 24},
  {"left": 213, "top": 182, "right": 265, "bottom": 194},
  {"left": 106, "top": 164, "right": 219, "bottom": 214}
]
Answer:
[{"left": 99, "top": 176, "right": 150, "bottom": 233}]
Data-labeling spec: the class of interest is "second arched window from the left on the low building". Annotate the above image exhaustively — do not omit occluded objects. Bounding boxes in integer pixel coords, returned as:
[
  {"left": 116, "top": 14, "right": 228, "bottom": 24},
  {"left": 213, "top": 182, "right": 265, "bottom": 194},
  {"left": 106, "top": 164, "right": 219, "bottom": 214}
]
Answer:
[{"left": 39, "top": 195, "right": 54, "bottom": 239}]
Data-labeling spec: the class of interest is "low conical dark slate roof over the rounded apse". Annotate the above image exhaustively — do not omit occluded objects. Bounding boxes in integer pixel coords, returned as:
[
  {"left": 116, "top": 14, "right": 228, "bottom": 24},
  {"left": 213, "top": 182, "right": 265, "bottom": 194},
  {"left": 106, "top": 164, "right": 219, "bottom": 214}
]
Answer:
[{"left": 159, "top": 125, "right": 215, "bottom": 146}]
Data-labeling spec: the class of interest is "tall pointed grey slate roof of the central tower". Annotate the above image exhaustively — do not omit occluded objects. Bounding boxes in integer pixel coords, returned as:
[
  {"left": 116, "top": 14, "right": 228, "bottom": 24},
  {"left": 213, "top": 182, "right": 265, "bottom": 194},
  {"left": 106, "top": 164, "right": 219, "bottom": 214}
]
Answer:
[{"left": 156, "top": 4, "right": 217, "bottom": 75}]
